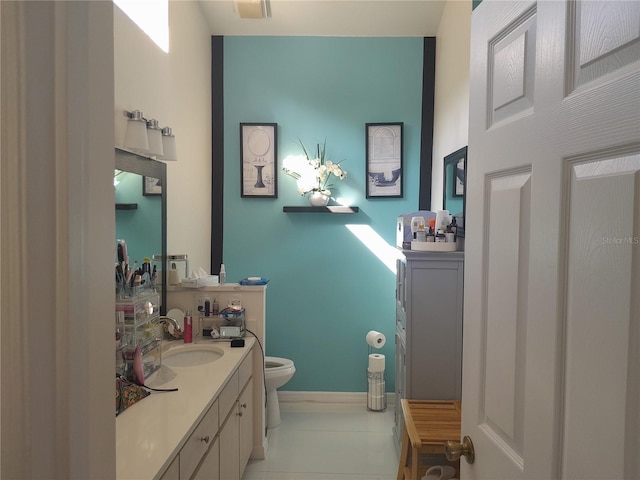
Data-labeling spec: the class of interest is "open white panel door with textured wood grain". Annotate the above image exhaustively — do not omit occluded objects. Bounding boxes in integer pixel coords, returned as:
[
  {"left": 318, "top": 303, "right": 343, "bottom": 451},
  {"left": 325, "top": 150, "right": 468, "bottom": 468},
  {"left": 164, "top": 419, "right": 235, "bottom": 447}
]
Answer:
[{"left": 461, "top": 0, "right": 640, "bottom": 480}]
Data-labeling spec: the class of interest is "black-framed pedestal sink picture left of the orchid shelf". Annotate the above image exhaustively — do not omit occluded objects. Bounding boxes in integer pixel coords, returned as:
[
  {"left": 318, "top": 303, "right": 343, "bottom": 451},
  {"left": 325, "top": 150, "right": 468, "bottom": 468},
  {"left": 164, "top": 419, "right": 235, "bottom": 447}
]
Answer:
[{"left": 240, "top": 123, "right": 278, "bottom": 198}]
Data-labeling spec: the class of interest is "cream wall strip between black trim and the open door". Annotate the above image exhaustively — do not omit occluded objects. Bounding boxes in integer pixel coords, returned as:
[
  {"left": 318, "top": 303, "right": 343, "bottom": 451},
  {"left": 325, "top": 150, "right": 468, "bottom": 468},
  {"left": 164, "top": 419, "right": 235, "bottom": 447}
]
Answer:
[{"left": 431, "top": 0, "right": 473, "bottom": 210}]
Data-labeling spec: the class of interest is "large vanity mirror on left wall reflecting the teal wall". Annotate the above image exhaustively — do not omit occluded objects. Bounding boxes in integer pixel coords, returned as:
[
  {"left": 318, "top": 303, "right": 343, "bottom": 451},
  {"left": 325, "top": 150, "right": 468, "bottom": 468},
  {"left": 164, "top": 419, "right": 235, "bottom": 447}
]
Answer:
[{"left": 113, "top": 148, "right": 167, "bottom": 315}]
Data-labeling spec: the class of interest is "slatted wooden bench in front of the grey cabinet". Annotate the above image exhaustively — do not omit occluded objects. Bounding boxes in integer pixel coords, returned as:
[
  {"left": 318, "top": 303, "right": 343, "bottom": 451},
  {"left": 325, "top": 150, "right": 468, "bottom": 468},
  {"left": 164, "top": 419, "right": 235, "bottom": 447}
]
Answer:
[{"left": 397, "top": 398, "right": 460, "bottom": 480}]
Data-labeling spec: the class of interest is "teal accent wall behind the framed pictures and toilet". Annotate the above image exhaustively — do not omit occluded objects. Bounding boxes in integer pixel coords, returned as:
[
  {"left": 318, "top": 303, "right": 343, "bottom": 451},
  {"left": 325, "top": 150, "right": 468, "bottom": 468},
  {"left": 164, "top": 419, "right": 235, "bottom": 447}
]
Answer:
[{"left": 225, "top": 37, "right": 423, "bottom": 392}]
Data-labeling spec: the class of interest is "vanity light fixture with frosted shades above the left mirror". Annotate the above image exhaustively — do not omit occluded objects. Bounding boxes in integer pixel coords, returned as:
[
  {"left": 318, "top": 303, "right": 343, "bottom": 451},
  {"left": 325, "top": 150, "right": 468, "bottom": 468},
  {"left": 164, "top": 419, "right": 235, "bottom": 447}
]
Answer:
[{"left": 123, "top": 110, "right": 178, "bottom": 161}]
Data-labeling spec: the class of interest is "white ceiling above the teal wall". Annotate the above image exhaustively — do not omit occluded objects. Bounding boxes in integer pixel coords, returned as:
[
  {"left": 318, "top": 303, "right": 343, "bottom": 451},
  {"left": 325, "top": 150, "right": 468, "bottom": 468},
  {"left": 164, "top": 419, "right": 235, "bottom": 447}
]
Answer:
[{"left": 198, "top": 0, "right": 448, "bottom": 37}]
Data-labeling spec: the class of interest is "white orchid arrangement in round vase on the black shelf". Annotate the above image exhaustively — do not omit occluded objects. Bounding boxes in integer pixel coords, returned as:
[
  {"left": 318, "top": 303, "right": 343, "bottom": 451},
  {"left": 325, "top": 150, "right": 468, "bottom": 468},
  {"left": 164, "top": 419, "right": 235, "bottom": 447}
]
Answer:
[{"left": 282, "top": 139, "right": 347, "bottom": 195}]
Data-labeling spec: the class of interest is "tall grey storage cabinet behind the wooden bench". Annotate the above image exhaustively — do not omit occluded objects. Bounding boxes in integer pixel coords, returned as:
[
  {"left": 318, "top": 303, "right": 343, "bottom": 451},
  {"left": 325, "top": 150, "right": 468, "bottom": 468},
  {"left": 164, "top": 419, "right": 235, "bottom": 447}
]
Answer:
[{"left": 394, "top": 250, "right": 464, "bottom": 445}]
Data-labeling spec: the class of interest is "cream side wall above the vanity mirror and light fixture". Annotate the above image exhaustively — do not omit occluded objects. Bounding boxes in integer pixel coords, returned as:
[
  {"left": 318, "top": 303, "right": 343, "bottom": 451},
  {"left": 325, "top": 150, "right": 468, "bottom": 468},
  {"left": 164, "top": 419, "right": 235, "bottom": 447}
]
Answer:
[{"left": 114, "top": 1, "right": 211, "bottom": 271}]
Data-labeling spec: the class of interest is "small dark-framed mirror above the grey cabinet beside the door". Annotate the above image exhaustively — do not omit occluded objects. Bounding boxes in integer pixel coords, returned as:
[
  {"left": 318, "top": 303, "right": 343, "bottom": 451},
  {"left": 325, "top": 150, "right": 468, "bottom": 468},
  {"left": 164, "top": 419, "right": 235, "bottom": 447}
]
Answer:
[{"left": 442, "top": 147, "right": 467, "bottom": 237}]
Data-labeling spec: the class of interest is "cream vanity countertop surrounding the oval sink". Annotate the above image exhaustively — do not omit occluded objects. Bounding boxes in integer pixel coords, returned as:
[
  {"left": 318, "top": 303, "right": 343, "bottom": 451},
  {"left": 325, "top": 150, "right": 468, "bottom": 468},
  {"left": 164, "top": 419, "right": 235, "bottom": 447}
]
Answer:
[{"left": 116, "top": 337, "right": 255, "bottom": 480}]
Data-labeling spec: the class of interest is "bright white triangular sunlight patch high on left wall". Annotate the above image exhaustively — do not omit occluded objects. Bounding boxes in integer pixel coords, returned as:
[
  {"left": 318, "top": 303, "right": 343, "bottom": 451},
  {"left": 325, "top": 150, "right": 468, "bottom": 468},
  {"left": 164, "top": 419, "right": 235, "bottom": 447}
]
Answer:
[{"left": 113, "top": 0, "right": 169, "bottom": 53}]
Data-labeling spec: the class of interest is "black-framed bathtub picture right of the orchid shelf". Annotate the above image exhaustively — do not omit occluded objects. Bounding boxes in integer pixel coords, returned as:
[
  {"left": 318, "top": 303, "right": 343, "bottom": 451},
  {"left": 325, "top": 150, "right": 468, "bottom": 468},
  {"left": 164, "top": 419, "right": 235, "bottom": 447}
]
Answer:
[{"left": 365, "top": 122, "right": 404, "bottom": 198}]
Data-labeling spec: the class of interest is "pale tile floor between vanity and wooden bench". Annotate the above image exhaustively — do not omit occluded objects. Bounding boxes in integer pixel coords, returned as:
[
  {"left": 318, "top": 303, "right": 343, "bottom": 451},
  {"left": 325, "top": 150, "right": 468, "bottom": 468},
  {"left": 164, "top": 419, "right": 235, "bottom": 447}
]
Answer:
[{"left": 242, "top": 403, "right": 398, "bottom": 480}]
